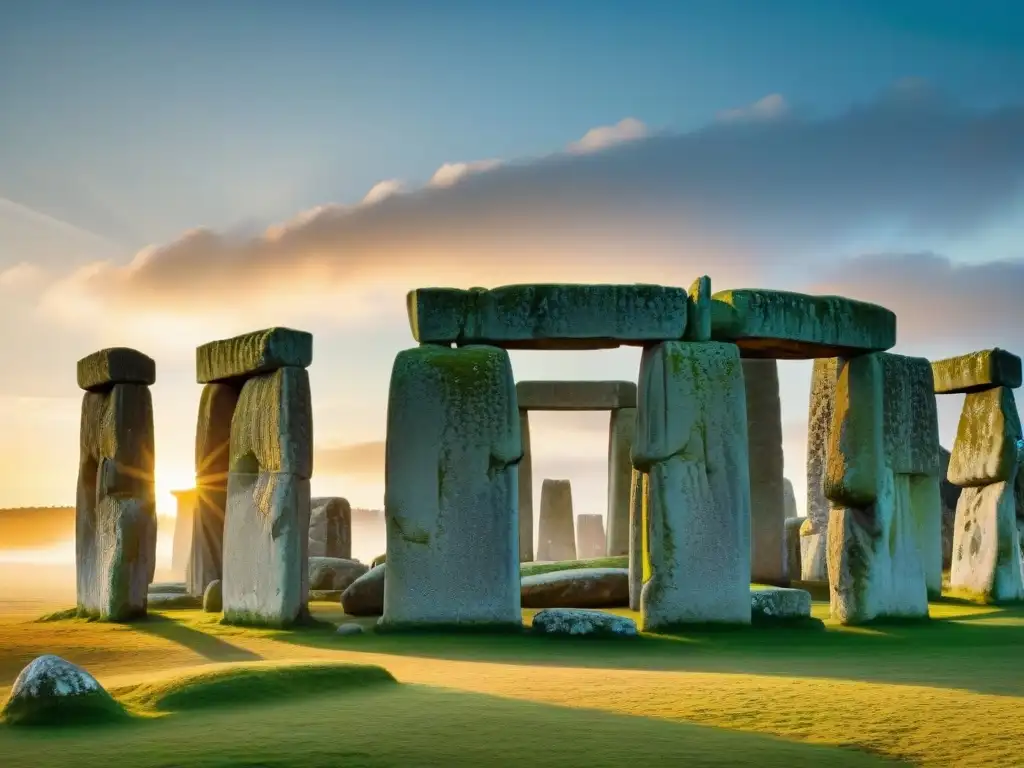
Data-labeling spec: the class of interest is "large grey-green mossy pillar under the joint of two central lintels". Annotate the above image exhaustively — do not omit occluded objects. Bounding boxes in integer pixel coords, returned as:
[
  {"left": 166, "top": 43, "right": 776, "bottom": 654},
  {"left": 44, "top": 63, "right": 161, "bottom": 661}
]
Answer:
[{"left": 633, "top": 342, "right": 751, "bottom": 631}]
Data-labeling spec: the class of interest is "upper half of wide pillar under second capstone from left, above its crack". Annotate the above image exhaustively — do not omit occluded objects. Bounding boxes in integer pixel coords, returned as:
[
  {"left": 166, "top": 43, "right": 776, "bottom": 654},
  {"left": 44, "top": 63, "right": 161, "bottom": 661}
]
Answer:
[{"left": 228, "top": 368, "right": 313, "bottom": 479}]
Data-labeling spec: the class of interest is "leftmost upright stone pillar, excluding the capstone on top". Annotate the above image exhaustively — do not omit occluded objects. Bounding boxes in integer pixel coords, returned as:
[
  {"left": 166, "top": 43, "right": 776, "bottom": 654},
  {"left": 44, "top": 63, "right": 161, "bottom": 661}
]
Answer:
[{"left": 75, "top": 384, "right": 157, "bottom": 621}]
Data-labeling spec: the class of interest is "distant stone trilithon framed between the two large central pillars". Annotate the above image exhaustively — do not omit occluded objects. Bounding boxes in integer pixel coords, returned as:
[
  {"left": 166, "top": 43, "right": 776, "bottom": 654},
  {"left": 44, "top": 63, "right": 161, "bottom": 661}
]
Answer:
[{"left": 515, "top": 381, "right": 637, "bottom": 562}]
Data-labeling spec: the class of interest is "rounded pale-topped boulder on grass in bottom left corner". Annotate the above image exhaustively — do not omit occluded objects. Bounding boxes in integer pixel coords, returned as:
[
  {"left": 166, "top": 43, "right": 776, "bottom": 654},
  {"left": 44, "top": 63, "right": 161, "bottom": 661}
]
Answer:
[{"left": 0, "top": 654, "right": 127, "bottom": 725}]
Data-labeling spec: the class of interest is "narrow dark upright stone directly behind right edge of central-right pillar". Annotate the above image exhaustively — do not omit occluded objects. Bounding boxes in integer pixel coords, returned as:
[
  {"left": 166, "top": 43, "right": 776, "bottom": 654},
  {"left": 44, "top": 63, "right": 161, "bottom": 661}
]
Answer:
[{"left": 742, "top": 359, "right": 787, "bottom": 584}]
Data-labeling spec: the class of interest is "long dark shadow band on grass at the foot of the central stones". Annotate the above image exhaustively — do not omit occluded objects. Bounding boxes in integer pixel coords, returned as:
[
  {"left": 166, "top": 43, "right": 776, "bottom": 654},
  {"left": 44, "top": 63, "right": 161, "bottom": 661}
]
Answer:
[{"left": 253, "top": 608, "right": 1024, "bottom": 695}]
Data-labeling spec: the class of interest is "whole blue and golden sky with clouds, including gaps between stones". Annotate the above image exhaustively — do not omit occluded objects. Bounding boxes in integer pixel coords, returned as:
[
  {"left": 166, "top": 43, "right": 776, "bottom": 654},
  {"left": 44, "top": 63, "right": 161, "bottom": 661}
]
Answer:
[{"left": 0, "top": 0, "right": 1024, "bottom": 561}]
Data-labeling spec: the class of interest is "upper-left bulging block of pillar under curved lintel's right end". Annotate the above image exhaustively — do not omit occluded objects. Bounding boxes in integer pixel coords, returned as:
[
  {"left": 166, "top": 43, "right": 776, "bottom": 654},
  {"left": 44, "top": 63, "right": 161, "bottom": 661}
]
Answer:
[{"left": 824, "top": 354, "right": 885, "bottom": 512}]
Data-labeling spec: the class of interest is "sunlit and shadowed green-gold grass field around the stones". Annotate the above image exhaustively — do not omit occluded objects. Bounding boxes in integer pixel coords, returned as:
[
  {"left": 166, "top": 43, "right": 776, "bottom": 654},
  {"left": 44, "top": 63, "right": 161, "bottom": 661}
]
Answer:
[{"left": 0, "top": 602, "right": 1024, "bottom": 768}]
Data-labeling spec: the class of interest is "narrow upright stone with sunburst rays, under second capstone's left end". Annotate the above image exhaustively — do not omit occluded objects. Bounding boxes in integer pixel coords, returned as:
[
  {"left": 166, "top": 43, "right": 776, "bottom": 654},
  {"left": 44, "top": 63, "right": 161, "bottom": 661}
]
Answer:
[{"left": 185, "top": 383, "right": 241, "bottom": 597}]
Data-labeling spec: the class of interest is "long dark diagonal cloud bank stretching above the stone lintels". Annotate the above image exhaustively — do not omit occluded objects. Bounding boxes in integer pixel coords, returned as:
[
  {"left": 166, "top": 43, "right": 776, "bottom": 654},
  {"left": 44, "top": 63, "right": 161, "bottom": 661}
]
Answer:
[{"left": 37, "top": 83, "right": 1024, "bottom": 329}]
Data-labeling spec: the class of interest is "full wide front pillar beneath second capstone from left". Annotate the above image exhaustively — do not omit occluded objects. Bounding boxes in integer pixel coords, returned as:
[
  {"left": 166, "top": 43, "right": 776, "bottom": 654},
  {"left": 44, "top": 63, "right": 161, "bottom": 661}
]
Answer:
[{"left": 222, "top": 368, "right": 312, "bottom": 627}]
